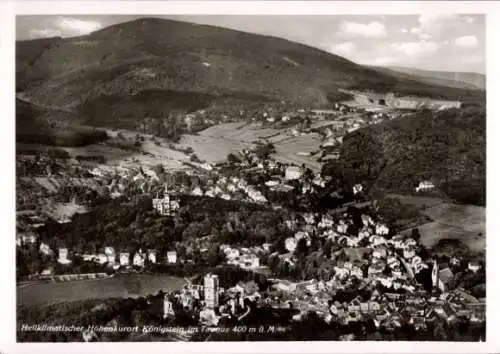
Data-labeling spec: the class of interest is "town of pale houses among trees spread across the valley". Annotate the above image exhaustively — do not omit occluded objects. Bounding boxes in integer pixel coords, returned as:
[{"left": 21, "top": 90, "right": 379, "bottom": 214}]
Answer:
[{"left": 17, "top": 98, "right": 485, "bottom": 340}]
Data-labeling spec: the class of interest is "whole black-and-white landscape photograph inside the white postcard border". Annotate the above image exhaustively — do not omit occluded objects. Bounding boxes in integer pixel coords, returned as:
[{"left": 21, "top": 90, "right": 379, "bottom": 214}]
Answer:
[{"left": 4, "top": 0, "right": 497, "bottom": 343}]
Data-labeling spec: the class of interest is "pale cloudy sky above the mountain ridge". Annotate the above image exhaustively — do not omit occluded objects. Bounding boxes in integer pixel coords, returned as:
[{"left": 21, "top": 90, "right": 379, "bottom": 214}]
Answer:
[{"left": 16, "top": 14, "right": 486, "bottom": 74}]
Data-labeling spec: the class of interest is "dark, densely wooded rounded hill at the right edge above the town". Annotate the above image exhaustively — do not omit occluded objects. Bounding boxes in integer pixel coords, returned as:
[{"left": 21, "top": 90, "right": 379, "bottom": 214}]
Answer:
[{"left": 337, "top": 108, "right": 486, "bottom": 205}]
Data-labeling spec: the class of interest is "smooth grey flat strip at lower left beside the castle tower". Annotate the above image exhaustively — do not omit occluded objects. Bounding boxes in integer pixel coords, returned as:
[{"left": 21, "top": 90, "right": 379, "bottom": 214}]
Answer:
[{"left": 17, "top": 275, "right": 185, "bottom": 306}]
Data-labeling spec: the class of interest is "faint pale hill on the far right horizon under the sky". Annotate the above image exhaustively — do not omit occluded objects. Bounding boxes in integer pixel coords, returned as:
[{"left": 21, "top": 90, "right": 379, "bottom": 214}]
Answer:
[{"left": 373, "top": 66, "right": 486, "bottom": 90}]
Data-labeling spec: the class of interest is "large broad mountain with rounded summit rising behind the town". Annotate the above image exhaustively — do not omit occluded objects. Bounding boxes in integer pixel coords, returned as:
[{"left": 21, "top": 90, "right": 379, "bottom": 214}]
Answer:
[{"left": 16, "top": 18, "right": 484, "bottom": 130}]
